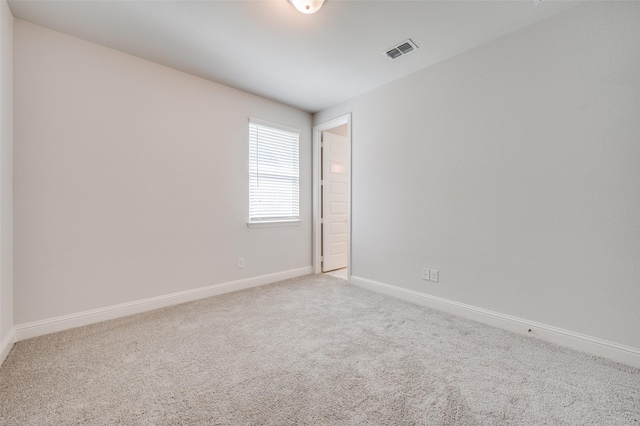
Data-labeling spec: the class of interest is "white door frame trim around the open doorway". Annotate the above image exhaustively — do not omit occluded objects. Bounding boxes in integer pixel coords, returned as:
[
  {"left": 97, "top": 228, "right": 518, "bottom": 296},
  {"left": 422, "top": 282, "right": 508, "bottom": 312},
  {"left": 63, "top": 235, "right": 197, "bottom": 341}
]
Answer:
[{"left": 313, "top": 113, "right": 351, "bottom": 281}]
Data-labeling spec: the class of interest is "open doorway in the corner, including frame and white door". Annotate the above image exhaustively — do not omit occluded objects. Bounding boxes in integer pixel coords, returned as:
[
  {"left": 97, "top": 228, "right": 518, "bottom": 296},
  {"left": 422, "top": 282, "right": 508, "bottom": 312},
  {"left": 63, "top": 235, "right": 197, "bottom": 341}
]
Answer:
[{"left": 313, "top": 114, "right": 351, "bottom": 281}]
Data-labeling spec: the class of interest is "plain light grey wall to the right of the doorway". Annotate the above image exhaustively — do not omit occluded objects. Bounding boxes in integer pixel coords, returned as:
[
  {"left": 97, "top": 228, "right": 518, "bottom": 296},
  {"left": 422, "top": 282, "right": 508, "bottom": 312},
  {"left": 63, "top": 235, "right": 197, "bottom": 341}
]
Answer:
[{"left": 314, "top": 2, "right": 640, "bottom": 348}]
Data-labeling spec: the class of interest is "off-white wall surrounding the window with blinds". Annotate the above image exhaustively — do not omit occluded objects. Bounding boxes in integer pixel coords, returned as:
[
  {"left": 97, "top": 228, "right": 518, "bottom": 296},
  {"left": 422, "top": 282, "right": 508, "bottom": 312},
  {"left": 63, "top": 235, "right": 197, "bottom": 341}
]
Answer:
[{"left": 14, "top": 20, "right": 312, "bottom": 325}]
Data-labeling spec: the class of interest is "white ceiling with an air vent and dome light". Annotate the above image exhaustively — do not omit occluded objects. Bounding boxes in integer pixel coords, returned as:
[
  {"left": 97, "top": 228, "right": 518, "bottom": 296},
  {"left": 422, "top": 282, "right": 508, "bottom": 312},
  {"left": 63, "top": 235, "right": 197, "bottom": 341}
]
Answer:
[{"left": 9, "top": 0, "right": 577, "bottom": 112}]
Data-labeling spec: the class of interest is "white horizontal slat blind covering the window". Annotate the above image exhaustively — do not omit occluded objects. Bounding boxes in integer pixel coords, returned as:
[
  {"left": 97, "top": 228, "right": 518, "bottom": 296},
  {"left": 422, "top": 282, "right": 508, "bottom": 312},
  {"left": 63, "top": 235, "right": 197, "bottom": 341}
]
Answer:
[{"left": 249, "top": 118, "right": 300, "bottom": 222}]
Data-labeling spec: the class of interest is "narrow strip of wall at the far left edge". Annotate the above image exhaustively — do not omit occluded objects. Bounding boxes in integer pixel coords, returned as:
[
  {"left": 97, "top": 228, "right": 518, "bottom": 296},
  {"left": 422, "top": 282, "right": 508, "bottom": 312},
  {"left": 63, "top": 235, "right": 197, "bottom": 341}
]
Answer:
[{"left": 0, "top": 0, "right": 13, "bottom": 364}]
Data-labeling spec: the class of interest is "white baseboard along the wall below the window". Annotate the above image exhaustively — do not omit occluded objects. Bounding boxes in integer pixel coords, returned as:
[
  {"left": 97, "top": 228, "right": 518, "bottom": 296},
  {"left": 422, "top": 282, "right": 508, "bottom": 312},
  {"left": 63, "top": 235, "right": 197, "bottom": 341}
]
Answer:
[{"left": 15, "top": 266, "right": 313, "bottom": 341}]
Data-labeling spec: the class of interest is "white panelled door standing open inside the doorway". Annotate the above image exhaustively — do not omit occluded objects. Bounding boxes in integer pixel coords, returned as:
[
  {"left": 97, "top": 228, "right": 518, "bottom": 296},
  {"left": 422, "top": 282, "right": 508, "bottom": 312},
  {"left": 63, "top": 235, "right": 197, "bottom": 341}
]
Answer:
[{"left": 321, "top": 132, "right": 347, "bottom": 272}]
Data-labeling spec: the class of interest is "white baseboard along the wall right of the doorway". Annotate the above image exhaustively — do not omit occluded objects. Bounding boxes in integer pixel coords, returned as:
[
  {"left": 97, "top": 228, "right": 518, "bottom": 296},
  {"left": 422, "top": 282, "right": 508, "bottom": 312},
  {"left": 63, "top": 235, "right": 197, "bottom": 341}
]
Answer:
[{"left": 350, "top": 275, "right": 640, "bottom": 368}]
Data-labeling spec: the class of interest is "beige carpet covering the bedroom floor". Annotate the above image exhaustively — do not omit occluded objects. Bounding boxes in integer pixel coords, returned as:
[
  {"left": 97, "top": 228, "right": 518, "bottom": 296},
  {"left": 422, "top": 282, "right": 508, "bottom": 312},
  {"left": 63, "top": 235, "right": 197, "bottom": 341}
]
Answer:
[{"left": 0, "top": 275, "right": 640, "bottom": 425}]
